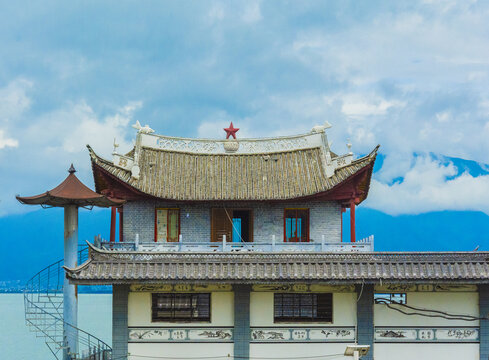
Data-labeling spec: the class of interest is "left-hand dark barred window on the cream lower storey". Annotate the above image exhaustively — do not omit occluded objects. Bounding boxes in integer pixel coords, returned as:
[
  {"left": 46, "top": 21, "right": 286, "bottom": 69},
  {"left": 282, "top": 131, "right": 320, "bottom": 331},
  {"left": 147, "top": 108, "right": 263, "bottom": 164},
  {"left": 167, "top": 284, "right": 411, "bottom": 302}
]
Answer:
[{"left": 151, "top": 293, "right": 211, "bottom": 322}]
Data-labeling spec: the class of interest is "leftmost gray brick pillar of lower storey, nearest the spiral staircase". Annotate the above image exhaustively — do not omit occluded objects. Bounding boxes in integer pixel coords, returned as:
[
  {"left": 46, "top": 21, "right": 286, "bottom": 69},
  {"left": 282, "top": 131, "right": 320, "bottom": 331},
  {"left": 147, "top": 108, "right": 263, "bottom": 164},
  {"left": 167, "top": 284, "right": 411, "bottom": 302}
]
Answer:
[{"left": 112, "top": 285, "right": 129, "bottom": 359}]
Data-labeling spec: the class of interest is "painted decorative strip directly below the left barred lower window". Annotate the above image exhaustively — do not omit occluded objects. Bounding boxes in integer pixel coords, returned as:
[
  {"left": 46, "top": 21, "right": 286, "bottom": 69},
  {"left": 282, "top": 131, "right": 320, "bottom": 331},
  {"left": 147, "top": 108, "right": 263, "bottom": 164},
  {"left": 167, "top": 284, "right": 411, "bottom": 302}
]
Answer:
[{"left": 129, "top": 327, "right": 233, "bottom": 342}]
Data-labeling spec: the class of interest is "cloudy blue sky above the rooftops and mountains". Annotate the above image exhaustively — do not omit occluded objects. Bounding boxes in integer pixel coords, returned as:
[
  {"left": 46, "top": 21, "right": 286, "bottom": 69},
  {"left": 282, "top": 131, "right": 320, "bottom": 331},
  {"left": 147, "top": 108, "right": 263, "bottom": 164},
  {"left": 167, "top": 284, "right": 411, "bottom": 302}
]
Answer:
[{"left": 0, "top": 0, "right": 489, "bottom": 268}]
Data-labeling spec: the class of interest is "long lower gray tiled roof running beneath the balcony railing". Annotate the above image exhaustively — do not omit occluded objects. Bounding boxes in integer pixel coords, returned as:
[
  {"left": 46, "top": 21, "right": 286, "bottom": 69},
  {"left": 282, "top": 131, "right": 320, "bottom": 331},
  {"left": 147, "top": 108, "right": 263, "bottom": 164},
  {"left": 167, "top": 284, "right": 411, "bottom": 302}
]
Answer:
[{"left": 67, "top": 247, "right": 489, "bottom": 284}]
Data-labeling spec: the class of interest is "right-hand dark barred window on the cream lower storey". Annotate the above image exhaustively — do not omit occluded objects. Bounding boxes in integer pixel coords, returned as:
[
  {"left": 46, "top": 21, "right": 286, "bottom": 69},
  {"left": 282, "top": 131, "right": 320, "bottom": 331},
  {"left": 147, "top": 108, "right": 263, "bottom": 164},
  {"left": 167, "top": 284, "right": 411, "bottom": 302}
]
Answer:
[{"left": 274, "top": 293, "right": 333, "bottom": 322}]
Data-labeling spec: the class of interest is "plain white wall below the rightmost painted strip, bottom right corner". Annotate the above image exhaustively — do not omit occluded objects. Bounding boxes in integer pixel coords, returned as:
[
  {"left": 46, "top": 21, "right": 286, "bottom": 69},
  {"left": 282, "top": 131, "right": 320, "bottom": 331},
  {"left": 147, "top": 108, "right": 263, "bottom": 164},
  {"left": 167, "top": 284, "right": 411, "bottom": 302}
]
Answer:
[{"left": 374, "top": 344, "right": 479, "bottom": 360}]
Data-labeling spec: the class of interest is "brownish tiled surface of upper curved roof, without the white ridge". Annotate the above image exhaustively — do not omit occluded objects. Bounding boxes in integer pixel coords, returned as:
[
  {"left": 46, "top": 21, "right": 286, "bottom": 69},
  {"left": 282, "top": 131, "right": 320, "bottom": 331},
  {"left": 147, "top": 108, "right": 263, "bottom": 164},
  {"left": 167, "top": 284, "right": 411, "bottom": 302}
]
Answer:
[{"left": 90, "top": 147, "right": 377, "bottom": 201}]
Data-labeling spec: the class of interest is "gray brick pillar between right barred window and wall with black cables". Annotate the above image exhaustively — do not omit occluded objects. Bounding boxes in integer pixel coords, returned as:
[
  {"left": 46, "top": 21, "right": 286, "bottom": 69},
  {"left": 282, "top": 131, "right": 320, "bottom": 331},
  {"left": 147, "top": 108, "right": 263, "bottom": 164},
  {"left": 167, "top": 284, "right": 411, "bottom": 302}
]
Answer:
[{"left": 356, "top": 284, "right": 374, "bottom": 360}]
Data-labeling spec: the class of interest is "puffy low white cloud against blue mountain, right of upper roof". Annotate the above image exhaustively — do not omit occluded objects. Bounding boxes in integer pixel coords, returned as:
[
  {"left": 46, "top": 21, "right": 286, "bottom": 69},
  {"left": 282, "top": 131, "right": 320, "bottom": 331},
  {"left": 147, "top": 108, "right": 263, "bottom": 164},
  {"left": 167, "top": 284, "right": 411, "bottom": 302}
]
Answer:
[{"left": 365, "top": 156, "right": 489, "bottom": 215}]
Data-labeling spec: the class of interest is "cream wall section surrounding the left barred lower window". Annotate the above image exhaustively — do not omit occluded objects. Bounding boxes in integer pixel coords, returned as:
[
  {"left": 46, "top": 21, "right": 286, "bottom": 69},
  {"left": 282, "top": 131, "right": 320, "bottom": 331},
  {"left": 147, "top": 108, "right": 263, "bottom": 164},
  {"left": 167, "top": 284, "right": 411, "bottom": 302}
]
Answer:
[{"left": 128, "top": 292, "right": 234, "bottom": 327}]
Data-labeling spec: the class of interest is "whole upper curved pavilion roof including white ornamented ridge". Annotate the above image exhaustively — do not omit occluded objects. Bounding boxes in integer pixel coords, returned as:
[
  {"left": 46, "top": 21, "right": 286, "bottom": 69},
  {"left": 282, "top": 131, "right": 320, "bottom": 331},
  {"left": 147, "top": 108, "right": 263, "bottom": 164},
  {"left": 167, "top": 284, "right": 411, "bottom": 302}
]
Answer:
[{"left": 89, "top": 129, "right": 378, "bottom": 203}]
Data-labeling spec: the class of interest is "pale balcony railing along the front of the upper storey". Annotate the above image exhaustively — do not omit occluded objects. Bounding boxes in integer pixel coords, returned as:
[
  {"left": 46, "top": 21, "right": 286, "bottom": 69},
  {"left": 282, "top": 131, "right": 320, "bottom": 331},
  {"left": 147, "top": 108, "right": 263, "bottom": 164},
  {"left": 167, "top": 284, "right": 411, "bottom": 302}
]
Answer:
[{"left": 95, "top": 235, "right": 374, "bottom": 253}]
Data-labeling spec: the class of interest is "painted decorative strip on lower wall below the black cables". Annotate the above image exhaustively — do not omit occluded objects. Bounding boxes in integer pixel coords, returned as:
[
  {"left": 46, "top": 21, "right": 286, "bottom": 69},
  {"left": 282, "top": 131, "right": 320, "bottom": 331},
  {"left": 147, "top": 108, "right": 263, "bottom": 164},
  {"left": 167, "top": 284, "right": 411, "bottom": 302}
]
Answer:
[{"left": 375, "top": 327, "right": 479, "bottom": 343}]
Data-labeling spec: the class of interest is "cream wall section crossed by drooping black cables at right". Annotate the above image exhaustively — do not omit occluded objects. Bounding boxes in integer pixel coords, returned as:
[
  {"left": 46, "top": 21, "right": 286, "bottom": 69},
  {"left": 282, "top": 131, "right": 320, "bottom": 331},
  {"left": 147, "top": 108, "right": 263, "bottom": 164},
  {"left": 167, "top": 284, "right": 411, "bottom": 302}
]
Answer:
[{"left": 374, "top": 292, "right": 479, "bottom": 326}]
